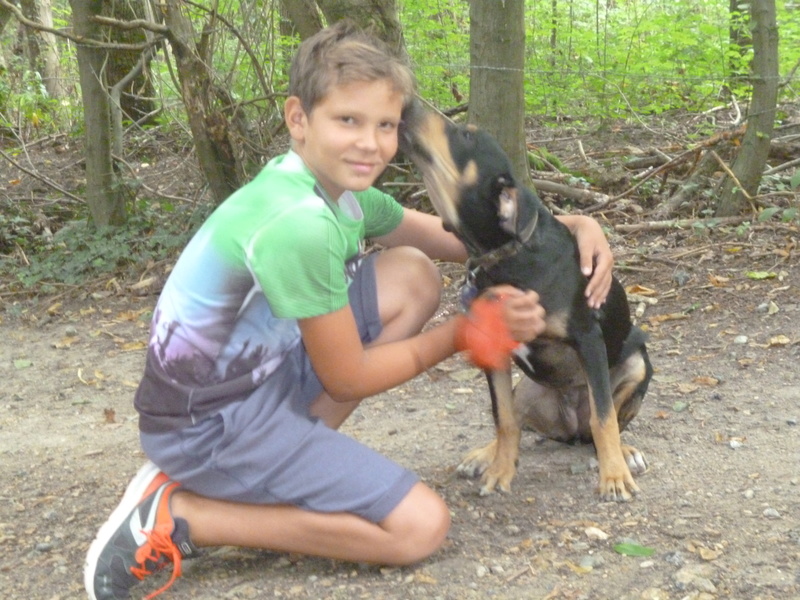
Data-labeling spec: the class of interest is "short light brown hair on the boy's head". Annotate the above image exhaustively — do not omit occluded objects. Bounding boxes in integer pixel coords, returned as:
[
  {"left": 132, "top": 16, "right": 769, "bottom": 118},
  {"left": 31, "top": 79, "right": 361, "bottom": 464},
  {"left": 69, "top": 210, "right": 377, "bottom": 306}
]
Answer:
[{"left": 289, "top": 20, "right": 416, "bottom": 114}]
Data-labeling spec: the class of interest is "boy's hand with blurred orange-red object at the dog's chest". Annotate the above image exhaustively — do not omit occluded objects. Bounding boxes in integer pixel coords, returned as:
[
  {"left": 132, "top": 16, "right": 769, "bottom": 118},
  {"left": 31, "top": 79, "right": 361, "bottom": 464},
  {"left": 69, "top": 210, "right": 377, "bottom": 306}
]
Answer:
[{"left": 455, "top": 286, "right": 545, "bottom": 370}]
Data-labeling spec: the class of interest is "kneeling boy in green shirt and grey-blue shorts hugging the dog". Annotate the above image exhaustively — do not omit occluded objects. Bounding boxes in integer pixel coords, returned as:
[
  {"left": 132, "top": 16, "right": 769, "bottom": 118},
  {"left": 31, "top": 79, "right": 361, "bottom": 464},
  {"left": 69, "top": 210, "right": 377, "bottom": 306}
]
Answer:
[{"left": 84, "top": 23, "right": 612, "bottom": 599}]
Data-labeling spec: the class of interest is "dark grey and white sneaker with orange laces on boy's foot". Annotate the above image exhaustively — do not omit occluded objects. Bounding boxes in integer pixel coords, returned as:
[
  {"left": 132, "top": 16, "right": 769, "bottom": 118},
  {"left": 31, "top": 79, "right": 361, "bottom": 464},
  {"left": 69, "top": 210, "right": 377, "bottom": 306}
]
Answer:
[{"left": 83, "top": 462, "right": 199, "bottom": 600}]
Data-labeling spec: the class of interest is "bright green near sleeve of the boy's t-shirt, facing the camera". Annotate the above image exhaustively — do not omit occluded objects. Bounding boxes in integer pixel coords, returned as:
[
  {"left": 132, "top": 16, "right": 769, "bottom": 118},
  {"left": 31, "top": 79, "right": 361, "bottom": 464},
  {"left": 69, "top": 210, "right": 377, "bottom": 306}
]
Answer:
[{"left": 245, "top": 207, "right": 348, "bottom": 319}]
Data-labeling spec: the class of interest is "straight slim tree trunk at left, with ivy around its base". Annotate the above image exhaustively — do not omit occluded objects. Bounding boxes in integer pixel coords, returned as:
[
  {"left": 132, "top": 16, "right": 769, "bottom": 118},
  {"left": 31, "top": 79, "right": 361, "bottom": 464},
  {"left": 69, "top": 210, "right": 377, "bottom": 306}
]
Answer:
[{"left": 70, "top": 0, "right": 126, "bottom": 227}]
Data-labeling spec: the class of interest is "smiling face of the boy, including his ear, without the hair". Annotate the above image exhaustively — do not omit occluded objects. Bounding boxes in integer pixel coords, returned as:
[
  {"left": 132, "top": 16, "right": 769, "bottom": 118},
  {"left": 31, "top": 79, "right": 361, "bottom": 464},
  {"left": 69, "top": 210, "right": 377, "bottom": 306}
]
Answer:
[{"left": 284, "top": 80, "right": 403, "bottom": 200}]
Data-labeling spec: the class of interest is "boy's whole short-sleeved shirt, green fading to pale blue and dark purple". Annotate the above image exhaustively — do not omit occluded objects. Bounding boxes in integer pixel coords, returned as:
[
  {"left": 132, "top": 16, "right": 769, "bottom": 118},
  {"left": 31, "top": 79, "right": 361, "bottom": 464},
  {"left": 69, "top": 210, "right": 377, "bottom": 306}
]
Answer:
[{"left": 135, "top": 152, "right": 403, "bottom": 433}]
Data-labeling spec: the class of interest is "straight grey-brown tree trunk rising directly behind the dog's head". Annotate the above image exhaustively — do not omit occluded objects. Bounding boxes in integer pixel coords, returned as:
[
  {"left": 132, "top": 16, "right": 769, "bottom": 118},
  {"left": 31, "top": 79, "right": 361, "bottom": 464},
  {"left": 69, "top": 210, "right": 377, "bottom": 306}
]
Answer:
[{"left": 469, "top": 0, "right": 533, "bottom": 187}]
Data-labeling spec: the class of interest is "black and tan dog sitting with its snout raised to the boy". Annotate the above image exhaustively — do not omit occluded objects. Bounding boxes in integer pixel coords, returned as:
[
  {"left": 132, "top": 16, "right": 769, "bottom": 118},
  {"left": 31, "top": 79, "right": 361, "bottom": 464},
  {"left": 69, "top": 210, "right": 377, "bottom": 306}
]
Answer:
[{"left": 400, "top": 105, "right": 653, "bottom": 501}]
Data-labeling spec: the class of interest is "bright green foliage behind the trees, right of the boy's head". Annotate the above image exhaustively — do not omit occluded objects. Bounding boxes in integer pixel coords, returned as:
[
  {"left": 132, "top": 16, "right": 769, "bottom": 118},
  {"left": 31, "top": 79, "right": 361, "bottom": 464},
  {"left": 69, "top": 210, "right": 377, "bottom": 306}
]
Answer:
[{"left": 400, "top": 0, "right": 800, "bottom": 118}]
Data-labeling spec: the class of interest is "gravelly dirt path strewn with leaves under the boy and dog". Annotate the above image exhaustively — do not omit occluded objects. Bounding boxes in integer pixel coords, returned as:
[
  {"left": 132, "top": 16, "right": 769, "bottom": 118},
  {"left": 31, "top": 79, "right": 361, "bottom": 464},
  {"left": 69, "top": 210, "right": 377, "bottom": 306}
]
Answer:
[{"left": 0, "top": 227, "right": 800, "bottom": 600}]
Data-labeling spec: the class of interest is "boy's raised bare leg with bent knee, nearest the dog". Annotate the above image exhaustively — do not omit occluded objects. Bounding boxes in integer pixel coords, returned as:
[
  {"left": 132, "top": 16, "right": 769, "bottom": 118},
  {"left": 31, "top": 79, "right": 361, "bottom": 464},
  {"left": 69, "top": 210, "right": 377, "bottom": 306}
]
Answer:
[{"left": 311, "top": 246, "right": 442, "bottom": 429}]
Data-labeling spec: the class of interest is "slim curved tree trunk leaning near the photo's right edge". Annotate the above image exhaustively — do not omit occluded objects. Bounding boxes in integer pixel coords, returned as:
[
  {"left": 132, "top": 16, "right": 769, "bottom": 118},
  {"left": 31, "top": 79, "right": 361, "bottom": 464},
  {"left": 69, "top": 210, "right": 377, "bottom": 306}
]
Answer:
[{"left": 716, "top": 0, "right": 778, "bottom": 217}]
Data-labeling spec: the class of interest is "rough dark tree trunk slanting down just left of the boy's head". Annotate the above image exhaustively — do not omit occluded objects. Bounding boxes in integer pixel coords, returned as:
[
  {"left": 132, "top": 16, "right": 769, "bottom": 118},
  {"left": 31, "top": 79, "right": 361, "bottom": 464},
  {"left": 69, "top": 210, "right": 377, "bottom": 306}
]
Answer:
[{"left": 164, "top": 0, "right": 241, "bottom": 203}]
